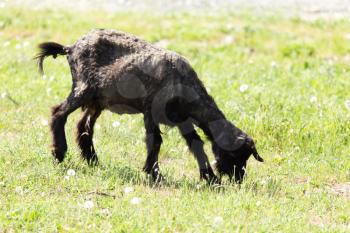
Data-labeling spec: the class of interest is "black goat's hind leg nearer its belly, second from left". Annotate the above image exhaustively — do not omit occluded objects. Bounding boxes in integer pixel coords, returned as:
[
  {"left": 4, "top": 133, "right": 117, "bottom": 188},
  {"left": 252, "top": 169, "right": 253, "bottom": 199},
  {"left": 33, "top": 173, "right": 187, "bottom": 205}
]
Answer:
[{"left": 76, "top": 107, "right": 101, "bottom": 165}]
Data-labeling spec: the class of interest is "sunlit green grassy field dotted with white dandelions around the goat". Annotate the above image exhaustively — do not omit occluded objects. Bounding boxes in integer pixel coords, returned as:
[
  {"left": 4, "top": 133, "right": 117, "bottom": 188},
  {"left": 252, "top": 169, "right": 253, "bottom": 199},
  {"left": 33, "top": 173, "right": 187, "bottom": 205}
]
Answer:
[{"left": 0, "top": 8, "right": 350, "bottom": 232}]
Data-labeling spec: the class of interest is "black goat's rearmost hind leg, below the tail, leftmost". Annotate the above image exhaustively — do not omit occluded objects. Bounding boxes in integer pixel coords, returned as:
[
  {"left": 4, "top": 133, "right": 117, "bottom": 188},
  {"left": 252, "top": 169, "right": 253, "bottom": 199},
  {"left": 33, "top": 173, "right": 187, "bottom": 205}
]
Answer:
[{"left": 50, "top": 92, "right": 84, "bottom": 162}]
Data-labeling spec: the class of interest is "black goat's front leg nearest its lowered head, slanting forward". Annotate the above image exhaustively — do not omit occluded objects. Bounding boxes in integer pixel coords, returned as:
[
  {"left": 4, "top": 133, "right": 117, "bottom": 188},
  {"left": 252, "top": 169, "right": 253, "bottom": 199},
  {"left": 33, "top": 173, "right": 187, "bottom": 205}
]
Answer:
[{"left": 179, "top": 122, "right": 220, "bottom": 184}]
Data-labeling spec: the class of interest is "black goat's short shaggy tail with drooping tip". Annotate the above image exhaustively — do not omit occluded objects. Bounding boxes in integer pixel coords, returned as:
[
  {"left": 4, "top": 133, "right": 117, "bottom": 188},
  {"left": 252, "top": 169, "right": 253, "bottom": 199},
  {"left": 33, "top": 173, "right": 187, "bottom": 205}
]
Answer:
[{"left": 34, "top": 42, "right": 70, "bottom": 74}]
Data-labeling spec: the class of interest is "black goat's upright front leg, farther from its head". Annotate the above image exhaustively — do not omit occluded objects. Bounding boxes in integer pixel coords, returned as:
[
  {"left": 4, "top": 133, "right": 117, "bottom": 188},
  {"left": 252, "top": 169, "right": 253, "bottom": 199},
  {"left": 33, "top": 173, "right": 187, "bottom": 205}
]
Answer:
[{"left": 143, "top": 113, "right": 163, "bottom": 182}]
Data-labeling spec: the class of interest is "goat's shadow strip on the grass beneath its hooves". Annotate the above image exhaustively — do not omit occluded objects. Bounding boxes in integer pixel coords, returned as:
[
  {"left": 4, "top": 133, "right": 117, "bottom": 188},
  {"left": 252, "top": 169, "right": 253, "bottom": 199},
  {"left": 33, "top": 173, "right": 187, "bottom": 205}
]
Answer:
[{"left": 56, "top": 152, "right": 254, "bottom": 193}]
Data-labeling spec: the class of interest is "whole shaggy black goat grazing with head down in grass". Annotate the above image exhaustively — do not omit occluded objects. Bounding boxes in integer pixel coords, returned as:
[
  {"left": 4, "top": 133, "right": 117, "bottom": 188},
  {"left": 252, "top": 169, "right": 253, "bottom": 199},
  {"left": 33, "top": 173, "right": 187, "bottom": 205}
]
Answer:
[{"left": 36, "top": 29, "right": 263, "bottom": 182}]
